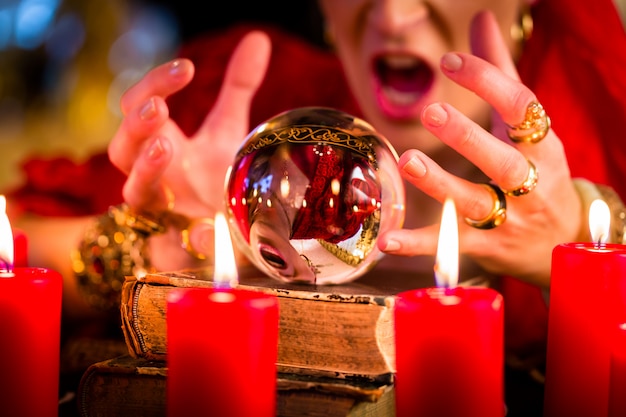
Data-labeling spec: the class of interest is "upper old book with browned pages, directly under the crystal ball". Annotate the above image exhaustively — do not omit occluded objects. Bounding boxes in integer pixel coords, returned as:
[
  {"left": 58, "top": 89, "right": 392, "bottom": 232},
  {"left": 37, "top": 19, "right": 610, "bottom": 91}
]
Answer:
[{"left": 121, "top": 269, "right": 434, "bottom": 379}]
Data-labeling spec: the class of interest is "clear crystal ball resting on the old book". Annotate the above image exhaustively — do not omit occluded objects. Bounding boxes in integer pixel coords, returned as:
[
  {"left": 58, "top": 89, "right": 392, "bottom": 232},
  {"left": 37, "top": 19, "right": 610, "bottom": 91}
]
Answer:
[{"left": 226, "top": 107, "right": 405, "bottom": 284}]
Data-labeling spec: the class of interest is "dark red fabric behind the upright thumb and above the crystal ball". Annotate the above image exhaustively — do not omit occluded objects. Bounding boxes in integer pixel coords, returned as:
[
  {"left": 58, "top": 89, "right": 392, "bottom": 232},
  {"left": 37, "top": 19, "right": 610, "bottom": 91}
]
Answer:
[{"left": 168, "top": 25, "right": 361, "bottom": 134}]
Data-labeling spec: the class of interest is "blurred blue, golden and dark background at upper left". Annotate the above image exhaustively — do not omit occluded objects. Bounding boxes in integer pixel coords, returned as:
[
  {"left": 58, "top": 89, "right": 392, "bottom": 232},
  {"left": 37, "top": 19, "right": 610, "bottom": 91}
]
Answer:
[{"left": 0, "top": 0, "right": 323, "bottom": 193}]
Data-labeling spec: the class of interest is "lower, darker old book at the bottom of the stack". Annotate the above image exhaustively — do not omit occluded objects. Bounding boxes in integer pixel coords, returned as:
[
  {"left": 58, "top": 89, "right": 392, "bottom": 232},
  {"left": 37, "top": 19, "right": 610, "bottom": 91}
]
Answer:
[{"left": 77, "top": 355, "right": 395, "bottom": 417}]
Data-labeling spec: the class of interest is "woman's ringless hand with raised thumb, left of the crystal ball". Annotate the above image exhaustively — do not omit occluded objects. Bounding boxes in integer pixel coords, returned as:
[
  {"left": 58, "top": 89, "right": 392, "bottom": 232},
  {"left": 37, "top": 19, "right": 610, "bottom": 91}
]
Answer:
[{"left": 108, "top": 31, "right": 271, "bottom": 269}]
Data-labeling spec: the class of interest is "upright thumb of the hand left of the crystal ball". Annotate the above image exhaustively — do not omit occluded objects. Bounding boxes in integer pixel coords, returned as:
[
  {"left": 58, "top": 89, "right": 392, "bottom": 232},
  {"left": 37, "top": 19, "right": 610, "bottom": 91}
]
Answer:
[{"left": 200, "top": 31, "right": 271, "bottom": 139}]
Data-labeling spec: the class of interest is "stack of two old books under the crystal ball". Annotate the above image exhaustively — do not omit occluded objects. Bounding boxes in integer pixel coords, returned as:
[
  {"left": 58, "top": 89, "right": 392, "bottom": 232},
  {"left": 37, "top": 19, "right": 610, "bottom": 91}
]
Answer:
[{"left": 78, "top": 269, "right": 433, "bottom": 417}]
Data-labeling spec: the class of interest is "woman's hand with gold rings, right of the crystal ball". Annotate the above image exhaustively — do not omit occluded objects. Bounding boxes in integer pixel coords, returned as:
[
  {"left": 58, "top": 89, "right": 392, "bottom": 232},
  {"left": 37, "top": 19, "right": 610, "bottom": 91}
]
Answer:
[{"left": 372, "top": 12, "right": 583, "bottom": 286}]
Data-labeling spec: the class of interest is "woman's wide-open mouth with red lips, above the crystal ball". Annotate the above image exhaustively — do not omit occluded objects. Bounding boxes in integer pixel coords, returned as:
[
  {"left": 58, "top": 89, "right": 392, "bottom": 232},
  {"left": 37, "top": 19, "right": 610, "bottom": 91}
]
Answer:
[{"left": 374, "top": 55, "right": 434, "bottom": 109}]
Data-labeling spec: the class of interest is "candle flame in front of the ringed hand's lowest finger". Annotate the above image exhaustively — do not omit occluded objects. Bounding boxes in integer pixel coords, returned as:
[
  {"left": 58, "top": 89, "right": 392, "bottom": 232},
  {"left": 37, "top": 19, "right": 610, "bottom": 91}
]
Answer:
[{"left": 435, "top": 198, "right": 459, "bottom": 288}]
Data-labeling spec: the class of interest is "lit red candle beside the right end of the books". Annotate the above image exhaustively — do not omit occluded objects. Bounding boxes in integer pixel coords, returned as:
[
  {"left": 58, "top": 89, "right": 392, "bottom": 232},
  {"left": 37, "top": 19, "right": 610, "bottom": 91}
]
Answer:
[{"left": 394, "top": 201, "right": 505, "bottom": 417}]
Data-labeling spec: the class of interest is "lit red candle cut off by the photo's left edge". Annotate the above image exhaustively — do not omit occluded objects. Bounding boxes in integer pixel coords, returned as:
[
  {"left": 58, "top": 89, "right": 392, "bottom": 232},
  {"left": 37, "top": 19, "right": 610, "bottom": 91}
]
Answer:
[{"left": 0, "top": 198, "right": 63, "bottom": 417}]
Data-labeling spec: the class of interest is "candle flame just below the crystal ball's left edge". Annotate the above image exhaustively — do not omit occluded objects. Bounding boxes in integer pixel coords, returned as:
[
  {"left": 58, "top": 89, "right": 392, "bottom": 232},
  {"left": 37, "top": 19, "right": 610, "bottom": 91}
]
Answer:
[{"left": 213, "top": 212, "right": 239, "bottom": 288}]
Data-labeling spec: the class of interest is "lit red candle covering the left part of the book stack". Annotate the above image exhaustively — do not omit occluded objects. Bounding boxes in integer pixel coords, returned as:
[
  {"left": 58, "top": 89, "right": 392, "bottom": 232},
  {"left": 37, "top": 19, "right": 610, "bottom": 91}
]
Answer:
[{"left": 167, "top": 214, "right": 278, "bottom": 417}]
